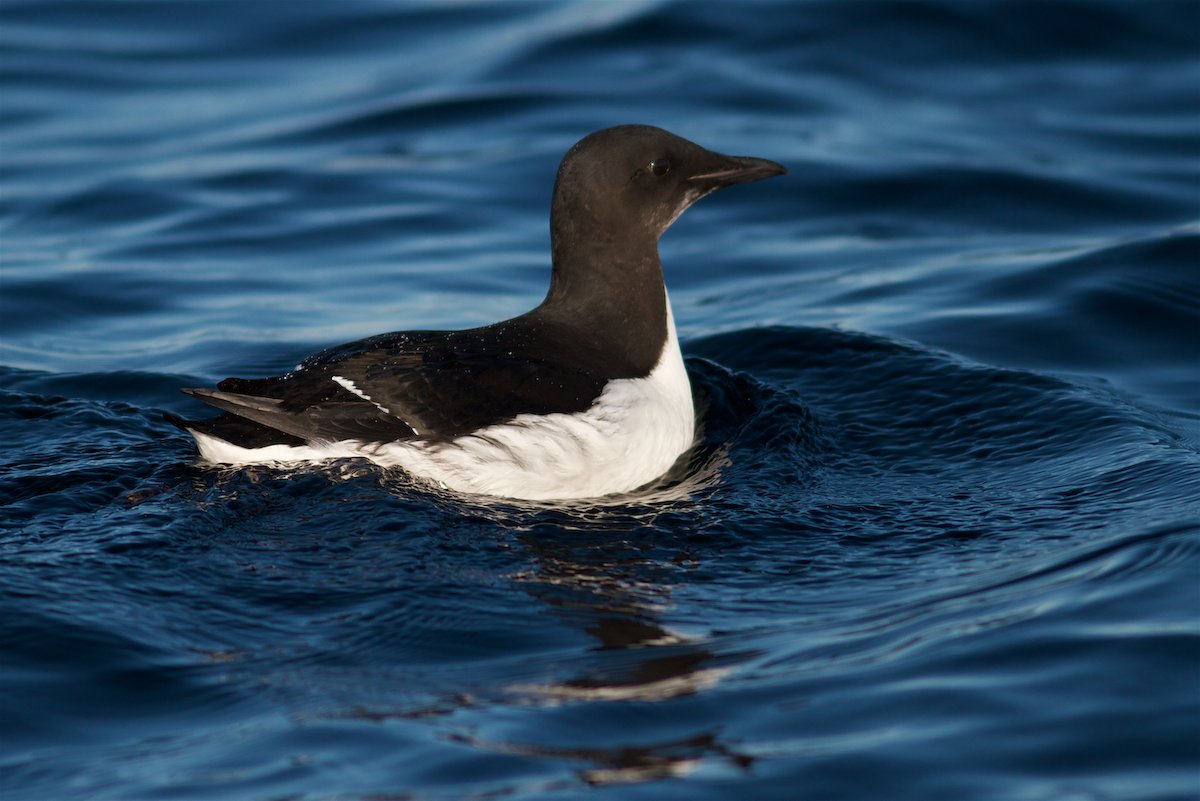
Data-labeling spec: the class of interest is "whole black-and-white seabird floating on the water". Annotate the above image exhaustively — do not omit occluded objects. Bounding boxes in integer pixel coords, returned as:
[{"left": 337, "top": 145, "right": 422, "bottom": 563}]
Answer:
[{"left": 167, "top": 125, "right": 787, "bottom": 500}]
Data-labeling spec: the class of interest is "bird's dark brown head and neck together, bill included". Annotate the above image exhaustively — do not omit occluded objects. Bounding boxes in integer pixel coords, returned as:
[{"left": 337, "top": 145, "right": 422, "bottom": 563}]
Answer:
[{"left": 537, "top": 125, "right": 787, "bottom": 378}]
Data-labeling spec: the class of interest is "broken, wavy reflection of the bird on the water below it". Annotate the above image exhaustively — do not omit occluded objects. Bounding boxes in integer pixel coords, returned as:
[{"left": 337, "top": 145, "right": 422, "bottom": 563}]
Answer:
[{"left": 454, "top": 527, "right": 754, "bottom": 785}]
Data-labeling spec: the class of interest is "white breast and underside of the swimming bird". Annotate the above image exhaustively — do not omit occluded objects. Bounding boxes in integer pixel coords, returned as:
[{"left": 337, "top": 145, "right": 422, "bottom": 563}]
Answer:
[{"left": 186, "top": 302, "right": 696, "bottom": 500}]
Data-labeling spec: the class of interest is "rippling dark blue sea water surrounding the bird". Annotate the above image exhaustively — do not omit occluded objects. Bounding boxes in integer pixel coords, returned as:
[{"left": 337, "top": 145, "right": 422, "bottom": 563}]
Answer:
[{"left": 0, "top": 0, "right": 1200, "bottom": 801}]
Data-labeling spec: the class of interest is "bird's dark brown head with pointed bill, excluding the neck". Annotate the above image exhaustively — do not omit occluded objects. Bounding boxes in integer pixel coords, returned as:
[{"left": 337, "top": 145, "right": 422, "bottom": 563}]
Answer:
[{"left": 551, "top": 125, "right": 787, "bottom": 242}]
